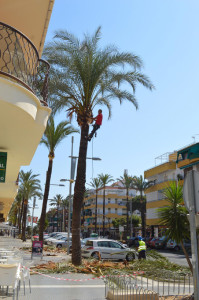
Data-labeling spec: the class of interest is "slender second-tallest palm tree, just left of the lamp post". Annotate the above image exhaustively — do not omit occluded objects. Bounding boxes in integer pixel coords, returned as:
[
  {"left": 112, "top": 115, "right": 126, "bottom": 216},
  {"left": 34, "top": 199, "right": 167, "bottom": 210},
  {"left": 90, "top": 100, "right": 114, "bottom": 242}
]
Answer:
[{"left": 39, "top": 116, "right": 78, "bottom": 241}]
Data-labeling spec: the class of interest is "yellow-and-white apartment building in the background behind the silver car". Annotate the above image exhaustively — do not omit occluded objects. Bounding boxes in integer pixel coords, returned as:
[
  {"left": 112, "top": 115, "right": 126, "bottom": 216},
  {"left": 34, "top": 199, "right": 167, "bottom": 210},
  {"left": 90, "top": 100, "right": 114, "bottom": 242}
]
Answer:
[{"left": 82, "top": 186, "right": 139, "bottom": 234}]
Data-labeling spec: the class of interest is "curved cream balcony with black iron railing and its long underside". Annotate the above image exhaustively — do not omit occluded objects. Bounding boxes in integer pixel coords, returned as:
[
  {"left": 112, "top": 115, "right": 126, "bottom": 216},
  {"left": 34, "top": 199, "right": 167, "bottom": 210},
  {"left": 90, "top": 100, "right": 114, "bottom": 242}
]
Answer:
[{"left": 0, "top": 22, "right": 51, "bottom": 216}]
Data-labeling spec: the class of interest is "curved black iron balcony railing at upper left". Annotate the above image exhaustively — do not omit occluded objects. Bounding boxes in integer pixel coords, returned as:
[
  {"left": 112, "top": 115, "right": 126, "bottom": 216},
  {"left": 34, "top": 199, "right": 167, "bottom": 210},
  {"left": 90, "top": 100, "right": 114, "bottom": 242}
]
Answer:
[{"left": 0, "top": 22, "right": 50, "bottom": 106}]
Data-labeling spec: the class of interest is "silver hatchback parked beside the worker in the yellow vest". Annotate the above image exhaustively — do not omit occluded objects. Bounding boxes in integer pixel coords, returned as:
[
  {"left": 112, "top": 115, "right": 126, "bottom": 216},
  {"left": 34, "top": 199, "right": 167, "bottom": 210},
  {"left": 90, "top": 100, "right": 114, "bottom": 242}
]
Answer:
[{"left": 82, "top": 239, "right": 135, "bottom": 261}]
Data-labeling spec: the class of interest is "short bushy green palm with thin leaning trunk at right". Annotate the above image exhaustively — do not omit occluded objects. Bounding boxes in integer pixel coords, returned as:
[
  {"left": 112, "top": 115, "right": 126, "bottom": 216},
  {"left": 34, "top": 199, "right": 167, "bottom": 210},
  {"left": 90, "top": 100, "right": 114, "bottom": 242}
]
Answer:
[{"left": 157, "top": 182, "right": 193, "bottom": 274}]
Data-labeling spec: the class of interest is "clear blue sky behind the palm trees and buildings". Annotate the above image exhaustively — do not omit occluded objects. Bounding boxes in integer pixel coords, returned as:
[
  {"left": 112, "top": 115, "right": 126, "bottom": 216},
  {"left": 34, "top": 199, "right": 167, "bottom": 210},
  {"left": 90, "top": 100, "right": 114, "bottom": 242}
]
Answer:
[{"left": 23, "top": 0, "right": 199, "bottom": 216}]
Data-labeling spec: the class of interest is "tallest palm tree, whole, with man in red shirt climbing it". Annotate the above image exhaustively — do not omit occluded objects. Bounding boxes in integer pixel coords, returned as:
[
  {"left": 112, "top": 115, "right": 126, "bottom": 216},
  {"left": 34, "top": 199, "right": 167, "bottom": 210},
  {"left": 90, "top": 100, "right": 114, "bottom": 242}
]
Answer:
[{"left": 44, "top": 27, "right": 154, "bottom": 265}]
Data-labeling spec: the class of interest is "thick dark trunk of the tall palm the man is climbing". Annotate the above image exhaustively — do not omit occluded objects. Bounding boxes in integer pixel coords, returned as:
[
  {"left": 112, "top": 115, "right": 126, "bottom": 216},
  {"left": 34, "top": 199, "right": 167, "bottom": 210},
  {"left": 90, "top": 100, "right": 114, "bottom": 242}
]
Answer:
[{"left": 72, "top": 125, "right": 89, "bottom": 266}]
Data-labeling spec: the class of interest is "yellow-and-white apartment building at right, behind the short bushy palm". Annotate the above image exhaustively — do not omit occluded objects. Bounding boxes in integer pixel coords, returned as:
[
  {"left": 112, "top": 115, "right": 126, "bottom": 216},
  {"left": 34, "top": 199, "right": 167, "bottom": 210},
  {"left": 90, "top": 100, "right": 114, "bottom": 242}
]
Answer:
[{"left": 144, "top": 152, "right": 184, "bottom": 236}]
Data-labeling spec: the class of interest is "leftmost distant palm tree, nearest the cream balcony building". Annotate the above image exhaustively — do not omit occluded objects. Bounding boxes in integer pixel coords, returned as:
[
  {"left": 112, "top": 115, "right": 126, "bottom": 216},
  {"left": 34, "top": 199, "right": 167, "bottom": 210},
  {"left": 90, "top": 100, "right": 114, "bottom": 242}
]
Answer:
[{"left": 19, "top": 170, "right": 42, "bottom": 241}]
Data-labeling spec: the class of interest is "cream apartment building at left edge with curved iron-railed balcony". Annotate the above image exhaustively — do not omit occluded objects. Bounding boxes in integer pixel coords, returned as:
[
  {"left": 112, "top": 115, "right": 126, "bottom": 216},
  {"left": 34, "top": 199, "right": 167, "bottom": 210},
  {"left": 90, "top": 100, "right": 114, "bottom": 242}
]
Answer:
[{"left": 0, "top": 0, "right": 54, "bottom": 222}]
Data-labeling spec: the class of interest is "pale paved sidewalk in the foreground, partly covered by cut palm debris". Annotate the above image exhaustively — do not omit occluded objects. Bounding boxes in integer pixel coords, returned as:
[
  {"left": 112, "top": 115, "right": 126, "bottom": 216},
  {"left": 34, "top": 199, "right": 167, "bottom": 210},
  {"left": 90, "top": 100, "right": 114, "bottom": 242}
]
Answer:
[{"left": 0, "top": 237, "right": 105, "bottom": 300}]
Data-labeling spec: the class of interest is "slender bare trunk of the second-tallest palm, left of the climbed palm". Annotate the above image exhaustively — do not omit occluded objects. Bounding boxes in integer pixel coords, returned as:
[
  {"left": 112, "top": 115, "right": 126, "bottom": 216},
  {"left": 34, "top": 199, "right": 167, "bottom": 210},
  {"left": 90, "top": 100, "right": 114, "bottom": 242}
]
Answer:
[{"left": 39, "top": 158, "right": 53, "bottom": 241}]
